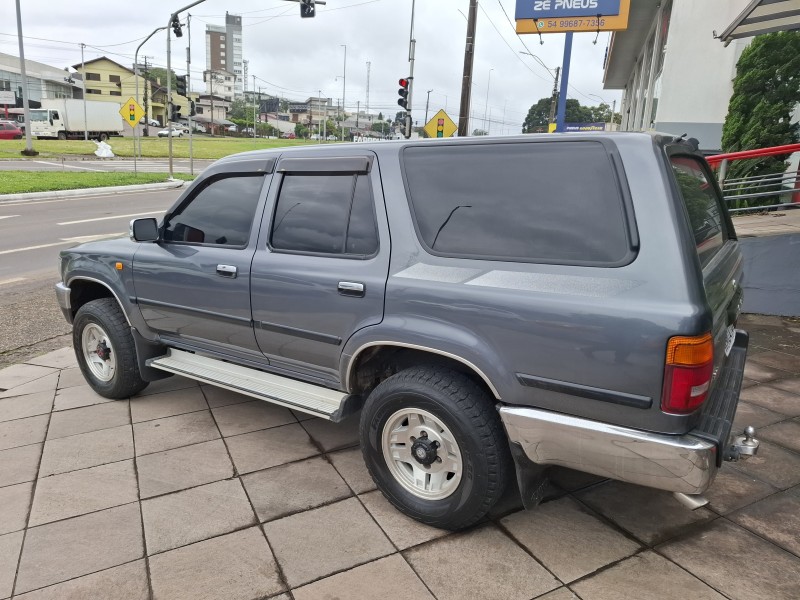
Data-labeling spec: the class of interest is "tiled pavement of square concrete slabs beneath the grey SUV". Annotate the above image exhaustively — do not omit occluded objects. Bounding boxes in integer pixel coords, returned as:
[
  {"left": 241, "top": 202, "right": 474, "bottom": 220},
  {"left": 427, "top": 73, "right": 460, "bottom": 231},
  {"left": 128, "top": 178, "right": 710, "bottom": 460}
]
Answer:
[{"left": 0, "top": 316, "right": 800, "bottom": 600}]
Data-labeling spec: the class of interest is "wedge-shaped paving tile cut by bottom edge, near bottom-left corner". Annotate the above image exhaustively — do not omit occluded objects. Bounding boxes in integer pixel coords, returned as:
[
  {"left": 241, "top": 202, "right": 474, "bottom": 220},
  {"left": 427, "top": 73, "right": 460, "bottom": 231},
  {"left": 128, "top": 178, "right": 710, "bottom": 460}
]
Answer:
[{"left": 15, "top": 560, "right": 150, "bottom": 600}]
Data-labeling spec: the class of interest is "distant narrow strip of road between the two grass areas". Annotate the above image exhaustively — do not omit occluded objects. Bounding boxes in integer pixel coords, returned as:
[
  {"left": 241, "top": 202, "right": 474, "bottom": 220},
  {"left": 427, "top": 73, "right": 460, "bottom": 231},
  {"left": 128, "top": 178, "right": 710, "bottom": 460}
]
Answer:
[{"left": 0, "top": 158, "right": 214, "bottom": 175}]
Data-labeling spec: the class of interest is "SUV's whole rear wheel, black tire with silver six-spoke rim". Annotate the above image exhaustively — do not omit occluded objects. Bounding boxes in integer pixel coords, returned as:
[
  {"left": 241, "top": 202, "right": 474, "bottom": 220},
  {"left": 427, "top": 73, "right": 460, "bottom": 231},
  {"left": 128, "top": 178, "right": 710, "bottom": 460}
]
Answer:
[{"left": 360, "top": 367, "right": 510, "bottom": 529}]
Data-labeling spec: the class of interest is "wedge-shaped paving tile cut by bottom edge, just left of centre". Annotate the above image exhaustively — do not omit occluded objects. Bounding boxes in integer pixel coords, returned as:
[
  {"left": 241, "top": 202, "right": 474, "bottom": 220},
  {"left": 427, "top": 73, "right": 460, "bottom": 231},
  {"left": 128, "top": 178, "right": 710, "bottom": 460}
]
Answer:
[{"left": 292, "top": 554, "right": 434, "bottom": 600}]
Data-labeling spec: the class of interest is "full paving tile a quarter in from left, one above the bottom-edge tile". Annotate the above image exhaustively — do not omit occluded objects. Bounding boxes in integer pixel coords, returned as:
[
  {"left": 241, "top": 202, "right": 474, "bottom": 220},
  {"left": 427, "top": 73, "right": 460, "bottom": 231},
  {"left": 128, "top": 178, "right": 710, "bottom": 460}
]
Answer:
[{"left": 142, "top": 479, "right": 256, "bottom": 555}]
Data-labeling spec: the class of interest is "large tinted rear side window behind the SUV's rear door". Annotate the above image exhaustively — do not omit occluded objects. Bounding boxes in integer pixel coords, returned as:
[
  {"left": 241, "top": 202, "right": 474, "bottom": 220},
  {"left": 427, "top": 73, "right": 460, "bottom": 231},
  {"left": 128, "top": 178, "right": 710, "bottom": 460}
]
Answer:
[{"left": 403, "top": 142, "right": 632, "bottom": 266}]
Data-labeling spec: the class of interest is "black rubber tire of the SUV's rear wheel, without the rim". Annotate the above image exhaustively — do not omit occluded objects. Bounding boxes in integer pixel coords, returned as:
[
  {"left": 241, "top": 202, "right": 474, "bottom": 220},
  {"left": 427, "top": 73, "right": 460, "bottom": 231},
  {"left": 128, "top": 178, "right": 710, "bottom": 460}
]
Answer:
[{"left": 360, "top": 367, "right": 511, "bottom": 530}]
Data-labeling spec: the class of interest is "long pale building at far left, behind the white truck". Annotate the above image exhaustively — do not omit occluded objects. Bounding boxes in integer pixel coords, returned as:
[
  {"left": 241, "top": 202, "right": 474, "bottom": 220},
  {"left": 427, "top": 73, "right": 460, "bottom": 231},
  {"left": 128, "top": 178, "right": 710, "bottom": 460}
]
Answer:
[{"left": 0, "top": 52, "right": 83, "bottom": 108}]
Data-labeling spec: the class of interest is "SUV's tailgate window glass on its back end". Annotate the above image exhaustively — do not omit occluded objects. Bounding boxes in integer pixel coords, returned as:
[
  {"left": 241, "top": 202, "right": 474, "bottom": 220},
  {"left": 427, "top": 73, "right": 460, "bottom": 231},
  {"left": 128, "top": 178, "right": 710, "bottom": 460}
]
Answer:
[{"left": 670, "top": 156, "right": 728, "bottom": 266}]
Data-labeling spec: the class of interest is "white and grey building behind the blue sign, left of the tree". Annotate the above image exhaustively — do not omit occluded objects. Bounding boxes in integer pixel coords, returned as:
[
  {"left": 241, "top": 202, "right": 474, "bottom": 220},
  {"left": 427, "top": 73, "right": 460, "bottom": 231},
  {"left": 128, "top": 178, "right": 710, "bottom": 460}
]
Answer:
[{"left": 603, "top": 0, "right": 750, "bottom": 151}]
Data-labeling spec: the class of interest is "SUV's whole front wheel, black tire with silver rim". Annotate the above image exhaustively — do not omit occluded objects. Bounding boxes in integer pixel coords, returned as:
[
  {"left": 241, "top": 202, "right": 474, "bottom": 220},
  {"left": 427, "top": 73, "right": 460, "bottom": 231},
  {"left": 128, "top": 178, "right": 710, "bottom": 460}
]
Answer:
[{"left": 72, "top": 298, "right": 148, "bottom": 400}]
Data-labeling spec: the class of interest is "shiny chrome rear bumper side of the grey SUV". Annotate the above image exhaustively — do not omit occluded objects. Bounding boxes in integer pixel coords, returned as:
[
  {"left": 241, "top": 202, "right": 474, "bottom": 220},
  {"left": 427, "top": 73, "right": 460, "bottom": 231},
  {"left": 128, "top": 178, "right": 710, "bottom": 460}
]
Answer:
[{"left": 500, "top": 406, "right": 717, "bottom": 494}]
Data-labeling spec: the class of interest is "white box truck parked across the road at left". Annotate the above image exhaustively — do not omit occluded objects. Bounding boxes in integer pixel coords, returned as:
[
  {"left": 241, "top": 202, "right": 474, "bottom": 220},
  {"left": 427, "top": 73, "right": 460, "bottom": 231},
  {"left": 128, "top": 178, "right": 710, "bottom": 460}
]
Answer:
[{"left": 30, "top": 99, "right": 124, "bottom": 142}]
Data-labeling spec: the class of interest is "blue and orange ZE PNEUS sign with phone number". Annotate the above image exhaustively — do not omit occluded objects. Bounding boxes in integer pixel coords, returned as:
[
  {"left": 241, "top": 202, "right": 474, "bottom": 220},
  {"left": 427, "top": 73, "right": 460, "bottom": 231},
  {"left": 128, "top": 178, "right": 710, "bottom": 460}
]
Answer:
[{"left": 516, "top": 0, "right": 631, "bottom": 33}]
